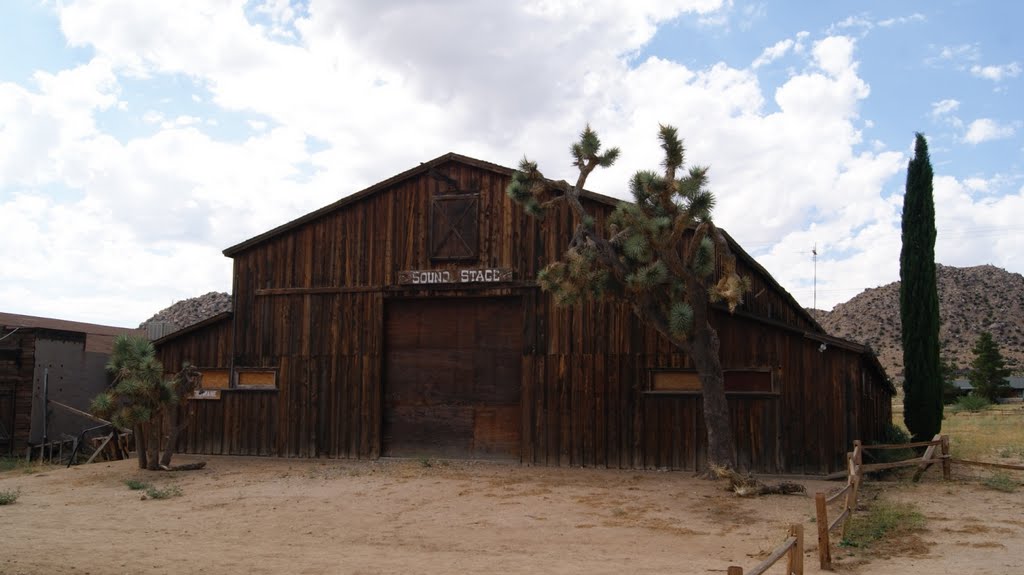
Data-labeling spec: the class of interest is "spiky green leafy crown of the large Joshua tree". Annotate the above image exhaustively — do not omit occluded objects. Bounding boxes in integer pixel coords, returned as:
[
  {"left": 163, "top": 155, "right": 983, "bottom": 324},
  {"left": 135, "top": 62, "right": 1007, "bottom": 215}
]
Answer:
[{"left": 507, "top": 126, "right": 750, "bottom": 339}]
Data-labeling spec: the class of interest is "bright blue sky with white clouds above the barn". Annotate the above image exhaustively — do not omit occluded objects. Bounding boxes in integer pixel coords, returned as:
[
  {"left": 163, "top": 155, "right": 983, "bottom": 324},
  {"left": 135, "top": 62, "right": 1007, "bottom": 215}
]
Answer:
[{"left": 0, "top": 0, "right": 1024, "bottom": 326}]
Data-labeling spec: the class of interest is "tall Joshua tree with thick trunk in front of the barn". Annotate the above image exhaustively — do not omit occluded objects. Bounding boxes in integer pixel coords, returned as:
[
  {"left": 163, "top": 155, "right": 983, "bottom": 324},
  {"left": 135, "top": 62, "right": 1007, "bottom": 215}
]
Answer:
[{"left": 508, "top": 126, "right": 750, "bottom": 469}]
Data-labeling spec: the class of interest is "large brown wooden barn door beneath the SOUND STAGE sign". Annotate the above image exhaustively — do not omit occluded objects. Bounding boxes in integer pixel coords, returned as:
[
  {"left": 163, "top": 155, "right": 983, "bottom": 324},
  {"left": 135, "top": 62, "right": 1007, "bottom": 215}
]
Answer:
[{"left": 383, "top": 298, "right": 522, "bottom": 459}]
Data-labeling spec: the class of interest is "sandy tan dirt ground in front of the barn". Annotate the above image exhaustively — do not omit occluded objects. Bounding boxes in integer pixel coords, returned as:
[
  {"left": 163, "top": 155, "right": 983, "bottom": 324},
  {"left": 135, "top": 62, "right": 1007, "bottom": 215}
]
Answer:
[{"left": 0, "top": 456, "right": 1024, "bottom": 575}]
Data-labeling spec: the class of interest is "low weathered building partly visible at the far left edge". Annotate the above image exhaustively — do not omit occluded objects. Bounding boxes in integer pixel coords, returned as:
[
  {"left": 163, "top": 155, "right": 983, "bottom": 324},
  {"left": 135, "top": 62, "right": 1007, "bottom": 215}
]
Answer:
[{"left": 0, "top": 312, "right": 141, "bottom": 454}]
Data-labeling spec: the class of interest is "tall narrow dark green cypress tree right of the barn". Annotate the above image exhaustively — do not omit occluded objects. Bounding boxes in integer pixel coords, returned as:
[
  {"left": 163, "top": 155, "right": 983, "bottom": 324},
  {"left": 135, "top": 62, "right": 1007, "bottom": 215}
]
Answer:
[{"left": 899, "top": 133, "right": 942, "bottom": 441}]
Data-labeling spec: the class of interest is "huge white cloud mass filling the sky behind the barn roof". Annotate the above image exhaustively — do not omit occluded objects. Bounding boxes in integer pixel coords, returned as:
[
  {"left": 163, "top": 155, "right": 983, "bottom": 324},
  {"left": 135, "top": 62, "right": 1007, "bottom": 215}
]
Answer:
[{"left": 0, "top": 0, "right": 1015, "bottom": 323}]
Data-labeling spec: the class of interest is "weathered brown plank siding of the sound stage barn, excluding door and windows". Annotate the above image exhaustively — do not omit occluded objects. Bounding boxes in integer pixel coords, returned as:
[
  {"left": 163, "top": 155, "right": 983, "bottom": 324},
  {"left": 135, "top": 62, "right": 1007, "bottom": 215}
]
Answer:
[{"left": 155, "top": 153, "right": 889, "bottom": 473}]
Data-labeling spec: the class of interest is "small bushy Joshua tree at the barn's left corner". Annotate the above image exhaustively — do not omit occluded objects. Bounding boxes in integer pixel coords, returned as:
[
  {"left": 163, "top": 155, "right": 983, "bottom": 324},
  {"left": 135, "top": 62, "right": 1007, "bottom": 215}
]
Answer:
[{"left": 91, "top": 336, "right": 199, "bottom": 470}]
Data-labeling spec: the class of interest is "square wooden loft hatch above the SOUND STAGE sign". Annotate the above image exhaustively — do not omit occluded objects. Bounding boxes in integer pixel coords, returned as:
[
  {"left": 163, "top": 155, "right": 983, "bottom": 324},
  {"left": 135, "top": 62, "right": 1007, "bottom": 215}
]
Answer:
[{"left": 430, "top": 193, "right": 480, "bottom": 261}]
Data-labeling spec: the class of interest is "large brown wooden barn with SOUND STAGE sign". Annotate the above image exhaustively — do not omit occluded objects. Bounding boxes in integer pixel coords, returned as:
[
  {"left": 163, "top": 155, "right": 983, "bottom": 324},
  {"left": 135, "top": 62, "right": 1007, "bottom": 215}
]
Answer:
[{"left": 156, "top": 153, "right": 894, "bottom": 474}]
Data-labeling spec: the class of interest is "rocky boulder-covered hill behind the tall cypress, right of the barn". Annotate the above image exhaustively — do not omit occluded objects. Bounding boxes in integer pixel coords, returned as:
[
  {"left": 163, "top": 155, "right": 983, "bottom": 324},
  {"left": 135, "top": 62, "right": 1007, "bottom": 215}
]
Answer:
[{"left": 812, "top": 265, "right": 1024, "bottom": 379}]
